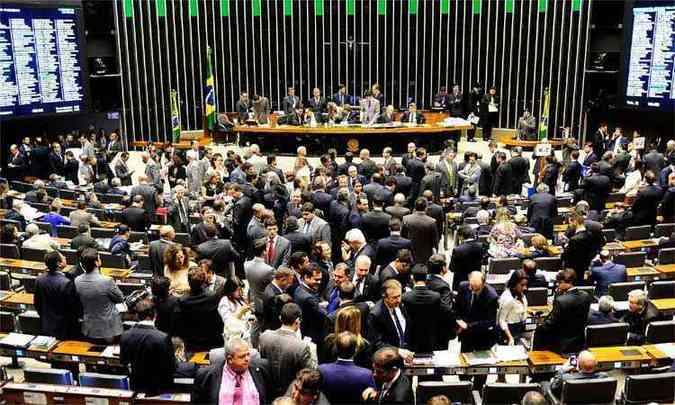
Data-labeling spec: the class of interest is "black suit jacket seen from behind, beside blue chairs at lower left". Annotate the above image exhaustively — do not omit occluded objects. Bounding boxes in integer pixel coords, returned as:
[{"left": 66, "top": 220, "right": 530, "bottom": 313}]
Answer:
[{"left": 120, "top": 324, "right": 176, "bottom": 396}]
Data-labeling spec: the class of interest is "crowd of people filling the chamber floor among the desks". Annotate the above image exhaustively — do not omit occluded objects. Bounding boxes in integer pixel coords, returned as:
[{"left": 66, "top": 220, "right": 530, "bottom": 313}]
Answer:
[{"left": 0, "top": 127, "right": 675, "bottom": 404}]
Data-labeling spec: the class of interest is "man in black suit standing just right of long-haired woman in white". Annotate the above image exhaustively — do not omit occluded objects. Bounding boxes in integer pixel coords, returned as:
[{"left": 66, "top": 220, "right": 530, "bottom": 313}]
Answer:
[{"left": 533, "top": 269, "right": 593, "bottom": 353}]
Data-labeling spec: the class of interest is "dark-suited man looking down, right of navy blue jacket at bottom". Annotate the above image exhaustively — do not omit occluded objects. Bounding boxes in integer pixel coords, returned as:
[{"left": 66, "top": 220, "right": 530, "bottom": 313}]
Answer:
[{"left": 362, "top": 347, "right": 415, "bottom": 405}]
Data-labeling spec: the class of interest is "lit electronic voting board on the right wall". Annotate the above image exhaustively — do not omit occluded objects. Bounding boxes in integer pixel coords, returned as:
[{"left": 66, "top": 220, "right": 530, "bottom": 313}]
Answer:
[{"left": 623, "top": 3, "right": 675, "bottom": 110}]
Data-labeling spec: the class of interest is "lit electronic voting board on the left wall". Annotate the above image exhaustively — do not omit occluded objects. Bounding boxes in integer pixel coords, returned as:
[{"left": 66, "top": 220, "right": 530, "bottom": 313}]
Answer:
[{"left": 0, "top": 3, "right": 86, "bottom": 119}]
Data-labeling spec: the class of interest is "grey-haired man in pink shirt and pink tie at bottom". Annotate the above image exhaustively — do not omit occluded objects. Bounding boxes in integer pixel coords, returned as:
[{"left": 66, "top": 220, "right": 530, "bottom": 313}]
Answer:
[{"left": 190, "top": 338, "right": 271, "bottom": 404}]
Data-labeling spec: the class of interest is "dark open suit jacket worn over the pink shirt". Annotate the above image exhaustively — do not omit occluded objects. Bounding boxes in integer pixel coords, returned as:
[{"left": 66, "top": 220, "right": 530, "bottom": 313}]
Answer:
[{"left": 190, "top": 358, "right": 271, "bottom": 404}]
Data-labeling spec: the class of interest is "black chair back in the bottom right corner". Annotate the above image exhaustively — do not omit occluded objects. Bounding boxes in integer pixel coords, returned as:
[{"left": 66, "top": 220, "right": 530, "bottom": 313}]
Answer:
[{"left": 623, "top": 372, "right": 675, "bottom": 405}]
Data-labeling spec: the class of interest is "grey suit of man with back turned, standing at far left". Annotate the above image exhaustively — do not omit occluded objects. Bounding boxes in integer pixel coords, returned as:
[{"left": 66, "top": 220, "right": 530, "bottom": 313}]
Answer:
[{"left": 75, "top": 270, "right": 124, "bottom": 338}]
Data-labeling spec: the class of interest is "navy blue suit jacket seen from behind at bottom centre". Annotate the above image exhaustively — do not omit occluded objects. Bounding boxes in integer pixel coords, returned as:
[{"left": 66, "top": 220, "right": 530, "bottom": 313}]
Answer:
[{"left": 319, "top": 360, "right": 375, "bottom": 405}]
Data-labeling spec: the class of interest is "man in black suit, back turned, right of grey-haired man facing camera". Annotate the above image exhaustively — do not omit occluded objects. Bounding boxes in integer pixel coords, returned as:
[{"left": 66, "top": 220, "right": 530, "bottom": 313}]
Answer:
[{"left": 403, "top": 264, "right": 455, "bottom": 353}]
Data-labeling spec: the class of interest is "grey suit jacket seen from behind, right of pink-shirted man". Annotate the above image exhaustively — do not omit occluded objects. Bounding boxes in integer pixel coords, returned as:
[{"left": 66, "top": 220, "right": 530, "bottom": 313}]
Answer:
[{"left": 258, "top": 328, "right": 316, "bottom": 397}]
